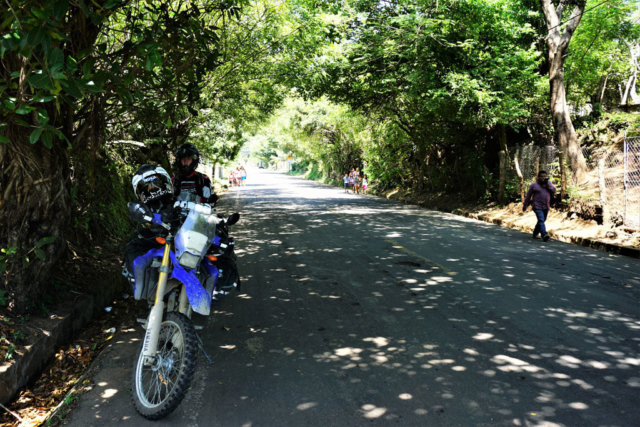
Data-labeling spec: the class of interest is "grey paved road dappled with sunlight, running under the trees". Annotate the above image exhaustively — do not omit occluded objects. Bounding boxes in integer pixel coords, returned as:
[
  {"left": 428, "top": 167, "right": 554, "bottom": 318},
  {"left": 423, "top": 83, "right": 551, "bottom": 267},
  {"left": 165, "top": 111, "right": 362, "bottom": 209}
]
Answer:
[{"left": 66, "top": 171, "right": 640, "bottom": 427}]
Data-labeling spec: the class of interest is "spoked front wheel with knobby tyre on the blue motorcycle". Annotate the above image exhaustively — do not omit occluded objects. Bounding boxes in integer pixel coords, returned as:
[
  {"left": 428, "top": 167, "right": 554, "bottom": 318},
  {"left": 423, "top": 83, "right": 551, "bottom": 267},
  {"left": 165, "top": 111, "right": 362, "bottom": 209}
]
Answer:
[{"left": 131, "top": 312, "right": 198, "bottom": 420}]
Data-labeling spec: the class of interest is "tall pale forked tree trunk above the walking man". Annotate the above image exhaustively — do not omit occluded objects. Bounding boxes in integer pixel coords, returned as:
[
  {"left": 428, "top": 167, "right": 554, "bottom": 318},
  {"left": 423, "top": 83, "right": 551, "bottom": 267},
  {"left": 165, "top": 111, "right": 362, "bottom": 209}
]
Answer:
[{"left": 540, "top": 0, "right": 587, "bottom": 184}]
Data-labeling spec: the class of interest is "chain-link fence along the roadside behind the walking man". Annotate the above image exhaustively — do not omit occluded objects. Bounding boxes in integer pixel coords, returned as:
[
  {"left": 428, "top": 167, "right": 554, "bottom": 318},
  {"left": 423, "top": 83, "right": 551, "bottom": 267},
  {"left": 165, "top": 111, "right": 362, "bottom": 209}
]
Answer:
[{"left": 507, "top": 134, "right": 640, "bottom": 229}]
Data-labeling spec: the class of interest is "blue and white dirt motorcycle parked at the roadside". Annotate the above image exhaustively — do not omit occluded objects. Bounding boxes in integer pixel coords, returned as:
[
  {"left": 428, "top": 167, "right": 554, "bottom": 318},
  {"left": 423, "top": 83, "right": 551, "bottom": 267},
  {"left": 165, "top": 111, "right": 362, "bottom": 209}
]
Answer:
[{"left": 128, "top": 200, "right": 240, "bottom": 420}]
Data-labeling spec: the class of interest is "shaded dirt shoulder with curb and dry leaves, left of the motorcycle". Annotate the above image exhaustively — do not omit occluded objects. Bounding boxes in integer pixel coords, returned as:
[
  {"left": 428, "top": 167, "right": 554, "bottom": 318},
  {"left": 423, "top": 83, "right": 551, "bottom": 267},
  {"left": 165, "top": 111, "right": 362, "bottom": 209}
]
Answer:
[{"left": 0, "top": 242, "right": 132, "bottom": 426}]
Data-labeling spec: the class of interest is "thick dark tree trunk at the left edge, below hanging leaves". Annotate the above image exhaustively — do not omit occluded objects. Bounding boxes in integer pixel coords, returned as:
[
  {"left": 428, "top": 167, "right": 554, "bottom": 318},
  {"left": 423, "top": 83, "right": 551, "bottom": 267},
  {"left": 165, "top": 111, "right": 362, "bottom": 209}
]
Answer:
[{"left": 0, "top": 126, "right": 70, "bottom": 313}]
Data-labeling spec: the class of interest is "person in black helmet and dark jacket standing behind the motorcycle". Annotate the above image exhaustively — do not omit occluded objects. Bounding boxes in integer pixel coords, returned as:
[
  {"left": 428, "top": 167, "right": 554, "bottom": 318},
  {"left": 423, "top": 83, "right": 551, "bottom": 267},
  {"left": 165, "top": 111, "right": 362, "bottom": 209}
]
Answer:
[{"left": 171, "top": 143, "right": 218, "bottom": 204}]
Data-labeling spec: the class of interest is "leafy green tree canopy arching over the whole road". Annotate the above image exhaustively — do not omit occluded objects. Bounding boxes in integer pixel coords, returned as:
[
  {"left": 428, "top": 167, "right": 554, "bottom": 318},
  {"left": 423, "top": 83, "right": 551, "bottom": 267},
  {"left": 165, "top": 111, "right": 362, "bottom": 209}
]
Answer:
[{"left": 0, "top": 0, "right": 640, "bottom": 309}]
